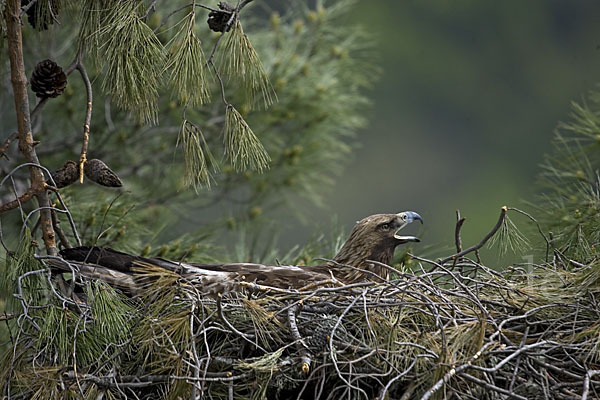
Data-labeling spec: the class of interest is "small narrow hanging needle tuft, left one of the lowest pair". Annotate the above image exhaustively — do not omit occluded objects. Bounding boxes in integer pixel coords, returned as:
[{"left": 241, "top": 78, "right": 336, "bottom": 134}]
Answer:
[{"left": 177, "top": 120, "right": 217, "bottom": 193}]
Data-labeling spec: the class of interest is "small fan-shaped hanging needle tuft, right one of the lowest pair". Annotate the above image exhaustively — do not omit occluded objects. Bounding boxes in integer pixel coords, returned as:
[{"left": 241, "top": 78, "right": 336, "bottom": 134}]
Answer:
[{"left": 223, "top": 104, "right": 271, "bottom": 171}]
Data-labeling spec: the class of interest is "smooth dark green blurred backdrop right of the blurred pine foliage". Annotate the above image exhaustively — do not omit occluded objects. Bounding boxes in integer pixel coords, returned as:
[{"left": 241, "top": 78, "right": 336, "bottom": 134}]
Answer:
[{"left": 304, "top": 0, "right": 600, "bottom": 253}]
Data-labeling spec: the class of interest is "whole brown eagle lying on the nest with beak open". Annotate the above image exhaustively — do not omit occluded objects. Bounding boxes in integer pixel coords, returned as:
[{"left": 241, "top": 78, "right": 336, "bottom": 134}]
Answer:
[{"left": 53, "top": 211, "right": 422, "bottom": 292}]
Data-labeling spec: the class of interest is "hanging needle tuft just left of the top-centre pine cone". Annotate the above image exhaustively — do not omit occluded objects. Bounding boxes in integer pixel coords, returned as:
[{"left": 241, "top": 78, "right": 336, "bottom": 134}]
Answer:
[{"left": 165, "top": 12, "right": 210, "bottom": 106}]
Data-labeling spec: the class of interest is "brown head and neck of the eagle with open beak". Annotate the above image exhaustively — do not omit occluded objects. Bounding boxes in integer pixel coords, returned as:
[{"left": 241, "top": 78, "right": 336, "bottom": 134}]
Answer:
[{"left": 332, "top": 211, "right": 423, "bottom": 282}]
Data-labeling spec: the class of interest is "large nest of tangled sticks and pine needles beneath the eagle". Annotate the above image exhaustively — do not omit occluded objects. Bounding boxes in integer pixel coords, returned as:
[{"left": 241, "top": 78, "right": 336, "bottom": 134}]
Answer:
[{"left": 1, "top": 217, "right": 600, "bottom": 400}]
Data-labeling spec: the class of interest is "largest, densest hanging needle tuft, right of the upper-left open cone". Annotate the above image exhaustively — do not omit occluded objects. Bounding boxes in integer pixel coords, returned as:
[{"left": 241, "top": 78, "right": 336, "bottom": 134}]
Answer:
[{"left": 99, "top": 2, "right": 164, "bottom": 123}]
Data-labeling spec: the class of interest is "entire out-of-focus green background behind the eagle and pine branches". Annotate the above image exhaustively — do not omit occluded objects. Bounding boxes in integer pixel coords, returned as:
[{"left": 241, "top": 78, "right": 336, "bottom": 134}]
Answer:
[{"left": 0, "top": 0, "right": 600, "bottom": 260}]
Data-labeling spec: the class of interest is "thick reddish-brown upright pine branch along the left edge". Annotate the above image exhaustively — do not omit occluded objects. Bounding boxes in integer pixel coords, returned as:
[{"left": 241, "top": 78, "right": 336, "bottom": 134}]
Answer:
[{"left": 4, "top": 0, "right": 58, "bottom": 255}]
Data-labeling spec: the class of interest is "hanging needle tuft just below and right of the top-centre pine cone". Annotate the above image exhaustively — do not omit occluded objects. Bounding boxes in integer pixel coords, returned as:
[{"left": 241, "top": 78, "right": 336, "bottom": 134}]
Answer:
[{"left": 220, "top": 20, "right": 277, "bottom": 108}]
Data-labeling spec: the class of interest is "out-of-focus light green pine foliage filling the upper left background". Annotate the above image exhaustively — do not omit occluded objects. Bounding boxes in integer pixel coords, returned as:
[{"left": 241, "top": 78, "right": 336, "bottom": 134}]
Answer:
[{"left": 0, "top": 0, "right": 378, "bottom": 261}]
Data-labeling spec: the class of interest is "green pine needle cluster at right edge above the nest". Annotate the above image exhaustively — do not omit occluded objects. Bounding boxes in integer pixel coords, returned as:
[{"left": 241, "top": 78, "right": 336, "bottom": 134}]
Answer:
[{"left": 533, "top": 91, "right": 600, "bottom": 262}]
